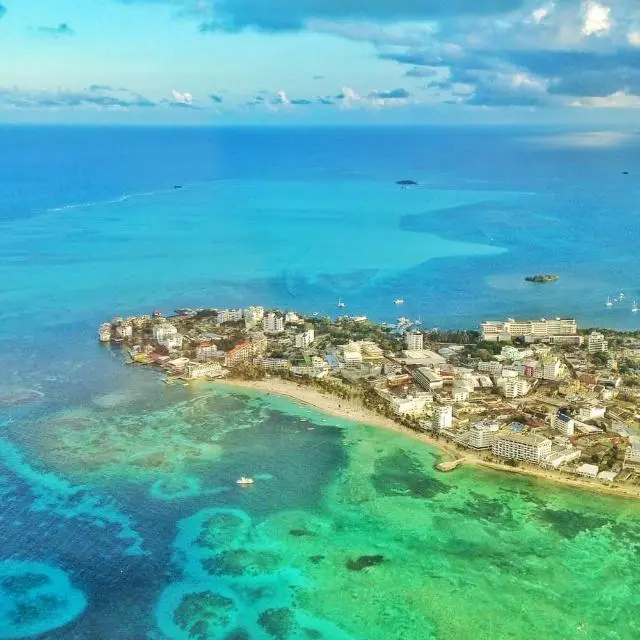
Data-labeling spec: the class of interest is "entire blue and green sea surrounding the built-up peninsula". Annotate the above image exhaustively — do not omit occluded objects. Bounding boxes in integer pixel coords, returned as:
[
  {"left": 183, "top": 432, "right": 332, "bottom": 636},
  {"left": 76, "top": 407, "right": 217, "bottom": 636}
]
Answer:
[{"left": 0, "top": 127, "right": 640, "bottom": 640}]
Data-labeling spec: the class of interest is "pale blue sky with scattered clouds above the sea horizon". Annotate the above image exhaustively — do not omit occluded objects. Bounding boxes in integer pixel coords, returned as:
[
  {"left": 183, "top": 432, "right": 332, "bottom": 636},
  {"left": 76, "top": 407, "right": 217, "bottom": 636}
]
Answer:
[{"left": 0, "top": 0, "right": 640, "bottom": 125}]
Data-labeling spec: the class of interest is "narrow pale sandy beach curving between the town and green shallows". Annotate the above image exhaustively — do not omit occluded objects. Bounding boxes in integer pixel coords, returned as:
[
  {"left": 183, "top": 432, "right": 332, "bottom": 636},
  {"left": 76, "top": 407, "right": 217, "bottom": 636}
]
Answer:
[{"left": 214, "top": 377, "right": 640, "bottom": 499}]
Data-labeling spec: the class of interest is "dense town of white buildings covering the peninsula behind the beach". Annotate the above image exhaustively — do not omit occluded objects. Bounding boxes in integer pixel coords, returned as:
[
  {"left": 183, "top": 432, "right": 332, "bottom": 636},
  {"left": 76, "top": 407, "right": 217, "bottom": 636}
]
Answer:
[{"left": 99, "top": 306, "right": 640, "bottom": 488}]
